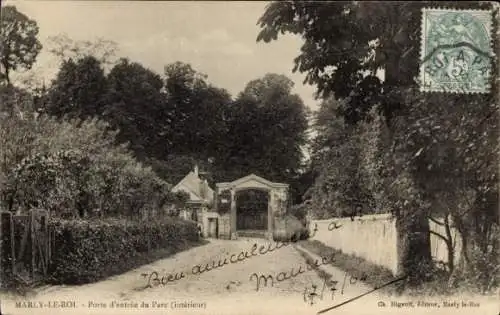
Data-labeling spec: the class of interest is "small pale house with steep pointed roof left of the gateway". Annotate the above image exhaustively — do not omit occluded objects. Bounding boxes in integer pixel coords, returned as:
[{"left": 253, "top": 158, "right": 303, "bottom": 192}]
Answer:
[{"left": 171, "top": 165, "right": 214, "bottom": 236}]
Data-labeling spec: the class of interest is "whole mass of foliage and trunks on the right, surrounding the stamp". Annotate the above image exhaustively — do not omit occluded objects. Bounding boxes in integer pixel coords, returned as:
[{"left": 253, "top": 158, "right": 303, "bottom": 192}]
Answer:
[{"left": 257, "top": 1, "right": 498, "bottom": 286}]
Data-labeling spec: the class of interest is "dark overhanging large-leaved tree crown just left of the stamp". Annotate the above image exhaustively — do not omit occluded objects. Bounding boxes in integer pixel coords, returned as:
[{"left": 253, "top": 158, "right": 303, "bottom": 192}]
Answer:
[{"left": 257, "top": 1, "right": 491, "bottom": 123}]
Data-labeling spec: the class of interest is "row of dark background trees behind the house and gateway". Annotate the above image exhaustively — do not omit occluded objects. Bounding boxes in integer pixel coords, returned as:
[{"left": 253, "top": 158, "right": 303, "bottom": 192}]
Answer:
[{"left": 33, "top": 46, "right": 308, "bottom": 189}]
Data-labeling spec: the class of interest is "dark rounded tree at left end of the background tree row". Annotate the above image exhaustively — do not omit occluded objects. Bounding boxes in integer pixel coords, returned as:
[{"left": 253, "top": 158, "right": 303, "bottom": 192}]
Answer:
[{"left": 43, "top": 56, "right": 107, "bottom": 119}]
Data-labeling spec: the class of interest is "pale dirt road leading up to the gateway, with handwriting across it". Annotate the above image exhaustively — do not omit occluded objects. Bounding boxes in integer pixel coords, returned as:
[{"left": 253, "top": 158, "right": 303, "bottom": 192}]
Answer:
[{"left": 1, "top": 239, "right": 498, "bottom": 315}]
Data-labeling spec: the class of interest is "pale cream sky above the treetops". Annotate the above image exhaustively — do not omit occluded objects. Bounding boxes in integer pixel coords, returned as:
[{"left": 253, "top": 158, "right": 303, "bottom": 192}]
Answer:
[{"left": 4, "top": 0, "right": 319, "bottom": 109}]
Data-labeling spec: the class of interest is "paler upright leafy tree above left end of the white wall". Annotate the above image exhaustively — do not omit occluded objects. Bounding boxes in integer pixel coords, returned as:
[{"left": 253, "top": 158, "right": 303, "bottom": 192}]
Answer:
[{"left": 306, "top": 98, "right": 376, "bottom": 218}]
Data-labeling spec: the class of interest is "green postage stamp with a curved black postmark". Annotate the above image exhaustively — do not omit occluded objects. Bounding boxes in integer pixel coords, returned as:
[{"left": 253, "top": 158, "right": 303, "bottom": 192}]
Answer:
[{"left": 420, "top": 9, "right": 493, "bottom": 93}]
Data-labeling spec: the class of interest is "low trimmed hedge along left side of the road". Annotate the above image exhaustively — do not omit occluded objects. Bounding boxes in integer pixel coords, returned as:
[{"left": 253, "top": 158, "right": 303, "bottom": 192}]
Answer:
[{"left": 49, "top": 217, "right": 200, "bottom": 284}]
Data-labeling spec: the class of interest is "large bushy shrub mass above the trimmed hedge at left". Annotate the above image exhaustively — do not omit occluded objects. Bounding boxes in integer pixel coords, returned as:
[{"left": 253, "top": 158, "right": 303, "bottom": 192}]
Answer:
[{"left": 0, "top": 107, "right": 183, "bottom": 217}]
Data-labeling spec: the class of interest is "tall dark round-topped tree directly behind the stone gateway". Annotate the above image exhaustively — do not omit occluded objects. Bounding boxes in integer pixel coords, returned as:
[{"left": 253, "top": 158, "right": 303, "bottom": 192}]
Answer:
[{"left": 225, "top": 74, "right": 308, "bottom": 181}]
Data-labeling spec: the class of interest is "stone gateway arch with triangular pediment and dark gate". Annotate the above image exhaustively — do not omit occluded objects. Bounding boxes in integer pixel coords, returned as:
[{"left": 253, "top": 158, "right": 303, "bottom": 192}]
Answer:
[{"left": 215, "top": 174, "right": 289, "bottom": 239}]
